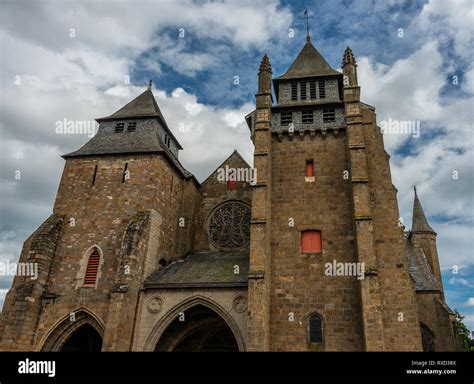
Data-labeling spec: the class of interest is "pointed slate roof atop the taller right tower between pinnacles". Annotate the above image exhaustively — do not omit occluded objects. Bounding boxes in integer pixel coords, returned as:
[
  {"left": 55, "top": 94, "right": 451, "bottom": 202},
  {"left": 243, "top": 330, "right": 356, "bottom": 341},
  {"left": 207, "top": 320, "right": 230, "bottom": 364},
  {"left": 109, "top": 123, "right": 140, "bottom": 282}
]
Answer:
[{"left": 274, "top": 36, "right": 341, "bottom": 80}]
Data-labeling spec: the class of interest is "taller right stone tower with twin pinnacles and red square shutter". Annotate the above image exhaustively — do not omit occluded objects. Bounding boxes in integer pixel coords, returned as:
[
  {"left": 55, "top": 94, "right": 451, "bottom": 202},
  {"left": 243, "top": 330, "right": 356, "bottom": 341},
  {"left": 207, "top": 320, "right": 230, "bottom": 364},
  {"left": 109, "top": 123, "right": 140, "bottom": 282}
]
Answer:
[{"left": 247, "top": 36, "right": 421, "bottom": 351}]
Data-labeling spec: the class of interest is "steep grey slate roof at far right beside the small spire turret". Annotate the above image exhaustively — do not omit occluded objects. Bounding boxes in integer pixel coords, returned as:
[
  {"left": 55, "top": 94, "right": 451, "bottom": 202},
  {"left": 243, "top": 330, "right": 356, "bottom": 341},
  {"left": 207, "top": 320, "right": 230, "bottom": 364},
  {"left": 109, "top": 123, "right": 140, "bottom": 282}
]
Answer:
[{"left": 405, "top": 239, "right": 440, "bottom": 291}]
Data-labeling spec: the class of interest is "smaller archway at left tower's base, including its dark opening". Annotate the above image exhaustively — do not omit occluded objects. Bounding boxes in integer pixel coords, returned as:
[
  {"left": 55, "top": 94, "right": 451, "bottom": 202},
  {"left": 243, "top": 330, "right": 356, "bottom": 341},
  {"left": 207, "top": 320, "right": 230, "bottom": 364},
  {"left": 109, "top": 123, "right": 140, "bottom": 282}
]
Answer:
[{"left": 40, "top": 309, "right": 104, "bottom": 352}]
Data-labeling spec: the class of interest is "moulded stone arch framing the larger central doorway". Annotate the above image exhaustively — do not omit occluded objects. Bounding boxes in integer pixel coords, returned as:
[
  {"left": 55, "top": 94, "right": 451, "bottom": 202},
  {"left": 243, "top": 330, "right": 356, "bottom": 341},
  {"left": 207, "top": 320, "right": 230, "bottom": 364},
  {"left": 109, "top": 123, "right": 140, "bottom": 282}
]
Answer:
[{"left": 145, "top": 295, "right": 245, "bottom": 352}]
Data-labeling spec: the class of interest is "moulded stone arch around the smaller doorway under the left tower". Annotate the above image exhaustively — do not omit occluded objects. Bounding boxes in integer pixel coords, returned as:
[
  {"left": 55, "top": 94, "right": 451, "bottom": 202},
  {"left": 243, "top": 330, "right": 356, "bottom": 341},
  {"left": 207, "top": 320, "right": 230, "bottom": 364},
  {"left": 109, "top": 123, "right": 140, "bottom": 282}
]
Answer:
[{"left": 38, "top": 308, "right": 105, "bottom": 352}]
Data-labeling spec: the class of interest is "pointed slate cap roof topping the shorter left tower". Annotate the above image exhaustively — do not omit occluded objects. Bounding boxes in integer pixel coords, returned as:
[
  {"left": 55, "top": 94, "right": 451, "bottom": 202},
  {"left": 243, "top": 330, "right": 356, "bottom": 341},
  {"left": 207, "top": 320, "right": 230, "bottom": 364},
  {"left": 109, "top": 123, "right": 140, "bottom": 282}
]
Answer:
[{"left": 97, "top": 84, "right": 166, "bottom": 124}]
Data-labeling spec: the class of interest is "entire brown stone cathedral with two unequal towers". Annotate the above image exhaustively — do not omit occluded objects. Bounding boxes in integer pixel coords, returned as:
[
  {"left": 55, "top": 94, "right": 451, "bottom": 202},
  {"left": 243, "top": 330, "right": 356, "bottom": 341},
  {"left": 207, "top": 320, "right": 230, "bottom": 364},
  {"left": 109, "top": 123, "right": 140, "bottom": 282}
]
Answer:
[{"left": 0, "top": 35, "right": 457, "bottom": 351}]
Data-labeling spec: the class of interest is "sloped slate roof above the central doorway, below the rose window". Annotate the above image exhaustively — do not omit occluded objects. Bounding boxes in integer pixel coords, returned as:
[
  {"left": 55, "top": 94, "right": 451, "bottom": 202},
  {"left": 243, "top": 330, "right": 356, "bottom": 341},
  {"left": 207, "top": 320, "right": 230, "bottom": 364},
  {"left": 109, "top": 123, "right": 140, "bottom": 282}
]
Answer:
[{"left": 144, "top": 252, "right": 249, "bottom": 288}]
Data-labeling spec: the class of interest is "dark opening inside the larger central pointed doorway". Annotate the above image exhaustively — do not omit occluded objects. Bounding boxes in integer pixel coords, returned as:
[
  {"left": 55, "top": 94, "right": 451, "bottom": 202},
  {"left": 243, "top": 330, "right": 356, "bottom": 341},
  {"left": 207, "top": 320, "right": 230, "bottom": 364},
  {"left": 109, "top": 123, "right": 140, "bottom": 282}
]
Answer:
[{"left": 155, "top": 304, "right": 239, "bottom": 352}]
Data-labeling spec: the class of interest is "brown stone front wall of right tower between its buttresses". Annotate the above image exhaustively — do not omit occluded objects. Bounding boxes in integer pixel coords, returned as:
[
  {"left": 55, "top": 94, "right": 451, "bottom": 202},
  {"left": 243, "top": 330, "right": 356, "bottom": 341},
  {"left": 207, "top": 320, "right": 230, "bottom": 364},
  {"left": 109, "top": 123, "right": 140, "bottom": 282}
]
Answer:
[{"left": 270, "top": 132, "right": 363, "bottom": 351}]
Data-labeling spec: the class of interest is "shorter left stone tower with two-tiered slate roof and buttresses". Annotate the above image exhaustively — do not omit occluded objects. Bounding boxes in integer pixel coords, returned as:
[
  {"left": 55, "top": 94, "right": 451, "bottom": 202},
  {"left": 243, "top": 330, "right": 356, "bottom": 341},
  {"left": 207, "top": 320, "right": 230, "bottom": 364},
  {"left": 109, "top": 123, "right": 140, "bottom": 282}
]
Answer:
[{"left": 0, "top": 82, "right": 198, "bottom": 351}]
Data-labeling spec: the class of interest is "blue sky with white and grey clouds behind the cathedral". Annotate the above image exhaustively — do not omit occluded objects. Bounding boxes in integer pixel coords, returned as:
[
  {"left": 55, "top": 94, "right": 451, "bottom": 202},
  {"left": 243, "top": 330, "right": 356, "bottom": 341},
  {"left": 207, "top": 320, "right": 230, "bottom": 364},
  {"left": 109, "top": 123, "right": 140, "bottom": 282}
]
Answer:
[{"left": 0, "top": 0, "right": 474, "bottom": 329}]
